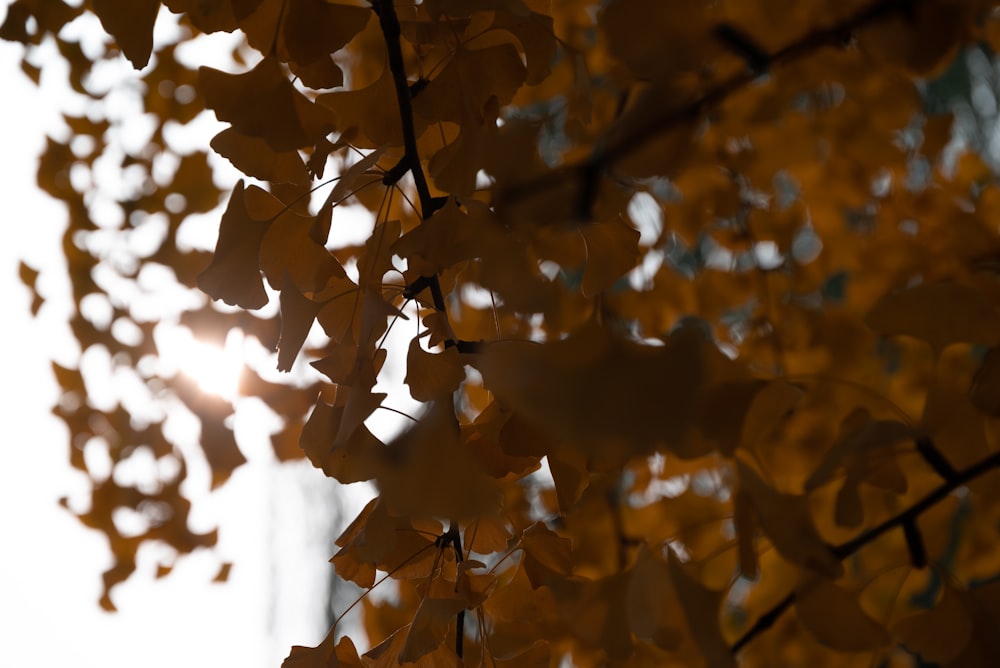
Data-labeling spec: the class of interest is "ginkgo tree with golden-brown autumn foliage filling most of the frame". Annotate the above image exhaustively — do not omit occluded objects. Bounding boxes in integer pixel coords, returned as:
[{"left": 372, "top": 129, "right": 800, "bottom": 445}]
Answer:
[{"left": 9, "top": 0, "right": 1000, "bottom": 668}]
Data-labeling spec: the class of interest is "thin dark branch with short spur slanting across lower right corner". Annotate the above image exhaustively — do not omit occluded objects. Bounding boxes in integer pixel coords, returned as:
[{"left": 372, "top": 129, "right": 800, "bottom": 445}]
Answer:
[{"left": 730, "top": 452, "right": 1000, "bottom": 654}]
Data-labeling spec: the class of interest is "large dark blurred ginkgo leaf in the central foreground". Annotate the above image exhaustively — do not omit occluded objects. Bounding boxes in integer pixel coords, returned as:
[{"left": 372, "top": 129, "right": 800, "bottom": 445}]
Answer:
[{"left": 474, "top": 324, "right": 742, "bottom": 457}]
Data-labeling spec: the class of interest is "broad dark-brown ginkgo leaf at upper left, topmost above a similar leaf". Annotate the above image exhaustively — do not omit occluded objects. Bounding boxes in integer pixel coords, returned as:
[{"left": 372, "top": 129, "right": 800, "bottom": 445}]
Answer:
[{"left": 198, "top": 58, "right": 334, "bottom": 152}]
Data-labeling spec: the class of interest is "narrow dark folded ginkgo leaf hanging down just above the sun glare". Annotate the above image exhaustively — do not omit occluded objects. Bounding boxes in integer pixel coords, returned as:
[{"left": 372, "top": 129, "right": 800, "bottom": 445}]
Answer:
[{"left": 198, "top": 181, "right": 269, "bottom": 309}]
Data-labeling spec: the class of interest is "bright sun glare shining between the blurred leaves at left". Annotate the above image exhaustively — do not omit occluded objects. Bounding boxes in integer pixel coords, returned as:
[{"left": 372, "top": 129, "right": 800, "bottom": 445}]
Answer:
[{"left": 157, "top": 327, "right": 244, "bottom": 401}]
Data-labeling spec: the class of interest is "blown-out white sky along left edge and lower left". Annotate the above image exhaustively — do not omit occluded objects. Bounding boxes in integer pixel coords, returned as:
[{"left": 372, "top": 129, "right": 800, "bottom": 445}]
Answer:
[{"left": 0, "top": 10, "right": 372, "bottom": 668}]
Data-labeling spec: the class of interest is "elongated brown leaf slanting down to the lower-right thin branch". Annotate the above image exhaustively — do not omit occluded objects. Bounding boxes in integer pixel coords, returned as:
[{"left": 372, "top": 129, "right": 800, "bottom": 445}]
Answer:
[{"left": 736, "top": 460, "right": 843, "bottom": 577}]
